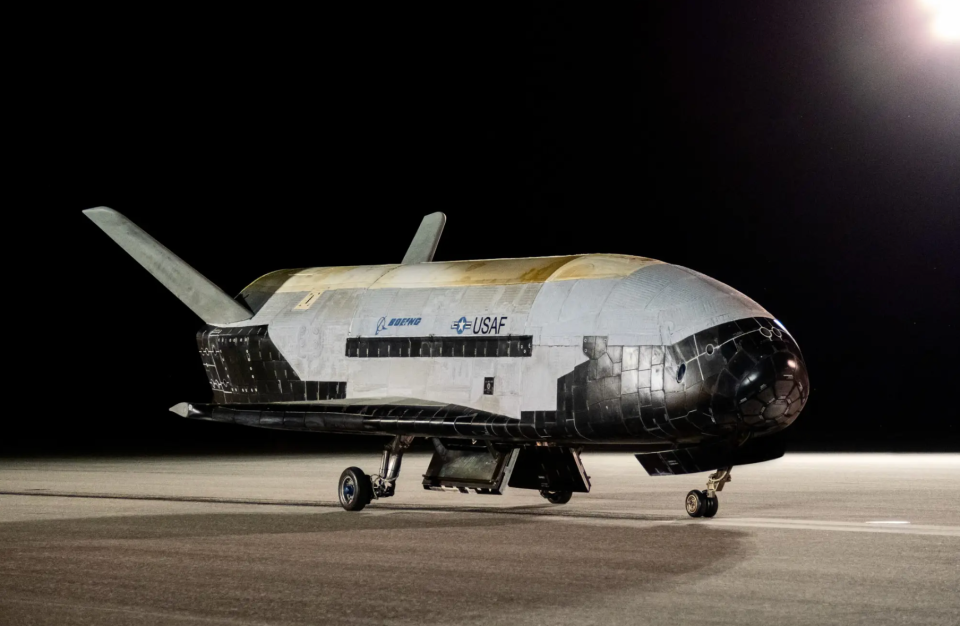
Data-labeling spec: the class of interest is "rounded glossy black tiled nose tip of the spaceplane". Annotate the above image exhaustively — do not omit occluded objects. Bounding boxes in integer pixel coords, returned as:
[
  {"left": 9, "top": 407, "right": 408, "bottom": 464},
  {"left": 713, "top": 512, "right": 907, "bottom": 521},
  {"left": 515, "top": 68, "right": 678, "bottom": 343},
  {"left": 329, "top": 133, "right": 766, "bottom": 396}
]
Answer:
[{"left": 713, "top": 318, "right": 810, "bottom": 433}]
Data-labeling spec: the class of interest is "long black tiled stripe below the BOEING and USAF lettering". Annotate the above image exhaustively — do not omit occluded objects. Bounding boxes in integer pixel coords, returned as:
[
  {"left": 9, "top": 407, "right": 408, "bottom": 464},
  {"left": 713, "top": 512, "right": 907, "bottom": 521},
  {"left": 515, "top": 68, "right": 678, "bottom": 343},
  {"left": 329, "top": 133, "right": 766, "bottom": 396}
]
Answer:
[{"left": 346, "top": 335, "right": 533, "bottom": 359}]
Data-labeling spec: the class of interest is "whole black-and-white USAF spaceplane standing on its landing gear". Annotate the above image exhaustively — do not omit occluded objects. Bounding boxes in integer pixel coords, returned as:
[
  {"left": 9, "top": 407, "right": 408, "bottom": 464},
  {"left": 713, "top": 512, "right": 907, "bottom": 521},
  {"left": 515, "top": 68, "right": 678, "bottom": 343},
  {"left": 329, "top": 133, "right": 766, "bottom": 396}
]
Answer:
[{"left": 84, "top": 207, "right": 810, "bottom": 517}]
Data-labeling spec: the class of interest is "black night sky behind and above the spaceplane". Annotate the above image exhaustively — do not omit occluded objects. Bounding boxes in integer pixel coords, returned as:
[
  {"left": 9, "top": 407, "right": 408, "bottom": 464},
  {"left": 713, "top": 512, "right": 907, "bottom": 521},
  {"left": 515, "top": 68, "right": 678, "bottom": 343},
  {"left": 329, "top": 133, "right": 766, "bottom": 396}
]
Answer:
[{"left": 13, "top": 0, "right": 960, "bottom": 454}]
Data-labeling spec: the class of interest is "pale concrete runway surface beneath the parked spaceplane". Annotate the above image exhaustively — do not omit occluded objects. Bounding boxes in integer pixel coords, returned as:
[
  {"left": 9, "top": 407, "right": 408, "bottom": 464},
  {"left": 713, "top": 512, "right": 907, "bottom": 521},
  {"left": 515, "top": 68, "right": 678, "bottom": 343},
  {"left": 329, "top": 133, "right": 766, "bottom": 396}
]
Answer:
[{"left": 0, "top": 454, "right": 960, "bottom": 626}]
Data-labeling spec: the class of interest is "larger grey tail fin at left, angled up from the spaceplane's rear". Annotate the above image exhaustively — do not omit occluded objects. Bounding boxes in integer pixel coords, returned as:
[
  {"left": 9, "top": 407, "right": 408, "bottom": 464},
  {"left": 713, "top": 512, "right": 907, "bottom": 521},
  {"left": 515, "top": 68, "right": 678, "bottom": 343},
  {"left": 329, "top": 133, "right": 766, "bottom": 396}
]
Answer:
[{"left": 83, "top": 207, "right": 253, "bottom": 324}]
